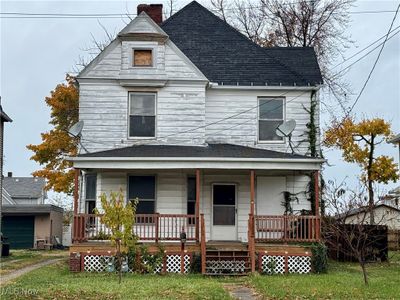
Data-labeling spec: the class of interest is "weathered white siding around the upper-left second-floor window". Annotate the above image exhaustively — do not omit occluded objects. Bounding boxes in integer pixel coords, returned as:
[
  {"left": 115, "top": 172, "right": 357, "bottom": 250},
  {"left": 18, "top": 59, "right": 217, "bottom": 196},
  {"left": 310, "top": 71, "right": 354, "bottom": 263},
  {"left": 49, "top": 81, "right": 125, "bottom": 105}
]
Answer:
[{"left": 79, "top": 83, "right": 205, "bottom": 152}]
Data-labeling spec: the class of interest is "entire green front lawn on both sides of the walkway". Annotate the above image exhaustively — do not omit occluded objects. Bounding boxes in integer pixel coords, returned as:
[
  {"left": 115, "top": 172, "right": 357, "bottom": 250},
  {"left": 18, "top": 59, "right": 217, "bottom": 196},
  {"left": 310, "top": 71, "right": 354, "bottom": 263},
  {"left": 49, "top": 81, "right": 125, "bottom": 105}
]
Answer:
[{"left": 1, "top": 253, "right": 400, "bottom": 300}]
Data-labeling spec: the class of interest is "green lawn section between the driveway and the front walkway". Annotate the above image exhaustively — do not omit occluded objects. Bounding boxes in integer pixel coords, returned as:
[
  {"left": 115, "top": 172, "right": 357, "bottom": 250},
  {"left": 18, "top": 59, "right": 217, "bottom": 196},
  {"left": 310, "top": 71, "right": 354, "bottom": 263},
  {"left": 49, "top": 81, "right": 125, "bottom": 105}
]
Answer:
[{"left": 1, "top": 262, "right": 230, "bottom": 300}]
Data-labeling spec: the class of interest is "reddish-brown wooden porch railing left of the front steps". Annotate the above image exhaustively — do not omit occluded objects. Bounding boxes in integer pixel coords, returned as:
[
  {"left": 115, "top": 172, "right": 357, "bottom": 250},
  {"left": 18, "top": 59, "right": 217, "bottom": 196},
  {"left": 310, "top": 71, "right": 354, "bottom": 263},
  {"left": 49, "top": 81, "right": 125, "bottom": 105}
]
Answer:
[{"left": 72, "top": 214, "right": 198, "bottom": 242}]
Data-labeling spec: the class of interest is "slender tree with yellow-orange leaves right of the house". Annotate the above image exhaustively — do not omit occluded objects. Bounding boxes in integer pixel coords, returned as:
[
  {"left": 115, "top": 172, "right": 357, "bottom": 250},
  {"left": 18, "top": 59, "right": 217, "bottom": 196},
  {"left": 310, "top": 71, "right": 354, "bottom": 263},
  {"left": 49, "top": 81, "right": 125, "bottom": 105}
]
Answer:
[{"left": 324, "top": 117, "right": 399, "bottom": 224}]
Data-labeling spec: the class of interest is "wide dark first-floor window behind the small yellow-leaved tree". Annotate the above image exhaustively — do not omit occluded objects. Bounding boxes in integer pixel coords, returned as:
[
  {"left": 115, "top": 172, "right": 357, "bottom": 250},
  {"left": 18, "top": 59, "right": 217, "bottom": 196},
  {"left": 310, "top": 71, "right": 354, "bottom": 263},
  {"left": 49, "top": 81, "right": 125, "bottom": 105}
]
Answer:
[{"left": 129, "top": 176, "right": 156, "bottom": 214}]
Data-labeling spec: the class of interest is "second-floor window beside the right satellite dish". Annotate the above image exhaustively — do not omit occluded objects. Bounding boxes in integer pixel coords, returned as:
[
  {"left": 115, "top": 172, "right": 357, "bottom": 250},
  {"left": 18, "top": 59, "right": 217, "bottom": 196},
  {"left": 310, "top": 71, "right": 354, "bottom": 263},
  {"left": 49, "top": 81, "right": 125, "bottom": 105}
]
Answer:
[{"left": 258, "top": 97, "right": 285, "bottom": 142}]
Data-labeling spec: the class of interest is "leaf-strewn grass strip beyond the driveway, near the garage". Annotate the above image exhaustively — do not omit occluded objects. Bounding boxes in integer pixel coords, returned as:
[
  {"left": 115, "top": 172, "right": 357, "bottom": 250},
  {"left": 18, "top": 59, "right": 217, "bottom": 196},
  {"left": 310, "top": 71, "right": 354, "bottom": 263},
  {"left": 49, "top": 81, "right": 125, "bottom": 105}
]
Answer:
[{"left": 0, "top": 250, "right": 68, "bottom": 275}]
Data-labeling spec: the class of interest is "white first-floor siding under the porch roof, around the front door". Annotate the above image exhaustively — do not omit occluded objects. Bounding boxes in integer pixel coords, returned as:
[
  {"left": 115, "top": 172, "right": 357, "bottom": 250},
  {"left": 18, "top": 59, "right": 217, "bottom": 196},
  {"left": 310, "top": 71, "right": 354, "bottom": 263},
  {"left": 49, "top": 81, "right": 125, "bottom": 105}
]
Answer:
[{"left": 81, "top": 170, "right": 310, "bottom": 241}]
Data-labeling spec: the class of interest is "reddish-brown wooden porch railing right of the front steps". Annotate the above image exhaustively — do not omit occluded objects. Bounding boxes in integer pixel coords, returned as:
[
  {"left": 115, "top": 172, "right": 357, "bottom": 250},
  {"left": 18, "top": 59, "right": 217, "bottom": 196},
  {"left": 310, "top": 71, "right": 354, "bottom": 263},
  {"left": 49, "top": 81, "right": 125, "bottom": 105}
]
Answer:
[{"left": 254, "top": 215, "right": 320, "bottom": 242}]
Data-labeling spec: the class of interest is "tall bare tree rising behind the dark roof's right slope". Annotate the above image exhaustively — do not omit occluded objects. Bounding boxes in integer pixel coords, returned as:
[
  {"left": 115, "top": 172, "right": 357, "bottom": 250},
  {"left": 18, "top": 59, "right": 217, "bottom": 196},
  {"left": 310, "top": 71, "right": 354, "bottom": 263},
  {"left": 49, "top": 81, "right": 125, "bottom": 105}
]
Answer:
[{"left": 211, "top": 0, "right": 354, "bottom": 108}]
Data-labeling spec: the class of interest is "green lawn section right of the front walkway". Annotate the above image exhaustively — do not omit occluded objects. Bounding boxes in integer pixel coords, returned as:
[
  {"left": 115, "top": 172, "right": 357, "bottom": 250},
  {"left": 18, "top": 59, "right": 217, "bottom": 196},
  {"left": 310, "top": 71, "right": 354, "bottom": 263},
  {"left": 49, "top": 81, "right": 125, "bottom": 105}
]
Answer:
[{"left": 246, "top": 252, "right": 400, "bottom": 299}]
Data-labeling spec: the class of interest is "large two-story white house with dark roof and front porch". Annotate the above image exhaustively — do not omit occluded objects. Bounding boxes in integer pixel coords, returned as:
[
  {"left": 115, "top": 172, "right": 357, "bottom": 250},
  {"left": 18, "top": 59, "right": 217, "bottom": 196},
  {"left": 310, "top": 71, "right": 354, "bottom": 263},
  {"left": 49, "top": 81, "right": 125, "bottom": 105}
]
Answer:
[{"left": 71, "top": 2, "right": 324, "bottom": 273}]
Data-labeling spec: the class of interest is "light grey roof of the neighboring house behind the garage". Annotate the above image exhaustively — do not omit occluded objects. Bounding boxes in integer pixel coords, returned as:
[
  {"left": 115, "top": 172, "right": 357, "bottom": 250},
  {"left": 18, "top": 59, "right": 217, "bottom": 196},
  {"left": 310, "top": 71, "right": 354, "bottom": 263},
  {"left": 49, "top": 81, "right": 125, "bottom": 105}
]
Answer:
[{"left": 3, "top": 177, "right": 46, "bottom": 198}]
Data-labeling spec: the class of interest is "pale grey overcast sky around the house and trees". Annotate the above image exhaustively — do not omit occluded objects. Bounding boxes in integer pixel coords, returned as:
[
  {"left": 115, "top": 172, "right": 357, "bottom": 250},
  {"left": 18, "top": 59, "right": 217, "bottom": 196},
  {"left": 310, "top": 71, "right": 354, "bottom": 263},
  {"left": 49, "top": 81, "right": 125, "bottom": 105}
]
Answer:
[{"left": 0, "top": 0, "right": 400, "bottom": 200}]
